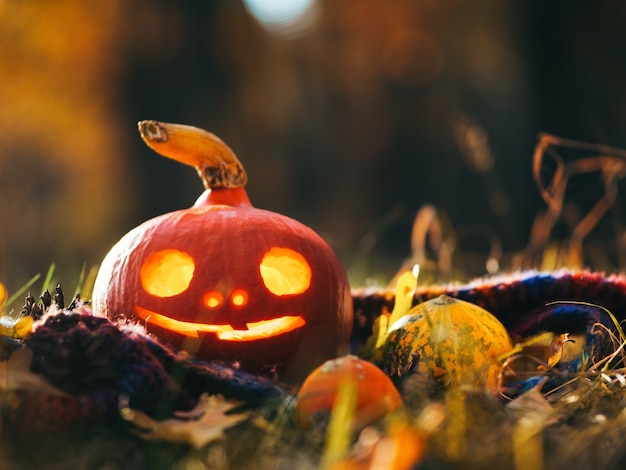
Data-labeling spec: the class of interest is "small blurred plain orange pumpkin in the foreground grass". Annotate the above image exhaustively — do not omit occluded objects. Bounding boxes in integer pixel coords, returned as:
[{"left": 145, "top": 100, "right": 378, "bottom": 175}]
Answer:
[{"left": 295, "top": 355, "right": 402, "bottom": 429}]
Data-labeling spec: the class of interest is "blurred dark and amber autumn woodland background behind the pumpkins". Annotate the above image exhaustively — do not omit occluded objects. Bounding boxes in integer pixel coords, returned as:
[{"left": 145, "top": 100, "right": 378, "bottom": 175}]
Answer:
[{"left": 0, "top": 0, "right": 626, "bottom": 290}]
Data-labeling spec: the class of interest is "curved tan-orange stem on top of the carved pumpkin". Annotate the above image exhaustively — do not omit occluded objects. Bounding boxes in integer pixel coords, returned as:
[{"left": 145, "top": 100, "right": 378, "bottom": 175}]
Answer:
[{"left": 138, "top": 121, "right": 248, "bottom": 189}]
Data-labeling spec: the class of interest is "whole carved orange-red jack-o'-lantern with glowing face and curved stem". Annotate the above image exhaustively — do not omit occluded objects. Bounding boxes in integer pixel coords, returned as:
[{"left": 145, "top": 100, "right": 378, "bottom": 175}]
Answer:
[{"left": 93, "top": 121, "right": 352, "bottom": 380}]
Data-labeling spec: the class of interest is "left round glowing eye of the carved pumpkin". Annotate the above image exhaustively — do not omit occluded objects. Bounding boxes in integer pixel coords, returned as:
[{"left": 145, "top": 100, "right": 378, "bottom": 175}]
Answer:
[{"left": 139, "top": 250, "right": 196, "bottom": 297}]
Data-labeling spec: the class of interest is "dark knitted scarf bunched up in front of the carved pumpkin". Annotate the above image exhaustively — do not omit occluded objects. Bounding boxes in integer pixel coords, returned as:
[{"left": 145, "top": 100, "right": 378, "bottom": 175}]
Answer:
[{"left": 2, "top": 311, "right": 284, "bottom": 438}]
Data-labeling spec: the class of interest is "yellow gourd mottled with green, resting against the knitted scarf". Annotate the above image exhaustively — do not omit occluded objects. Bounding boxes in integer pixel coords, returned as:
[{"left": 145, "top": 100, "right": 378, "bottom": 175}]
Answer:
[{"left": 382, "top": 295, "right": 512, "bottom": 391}]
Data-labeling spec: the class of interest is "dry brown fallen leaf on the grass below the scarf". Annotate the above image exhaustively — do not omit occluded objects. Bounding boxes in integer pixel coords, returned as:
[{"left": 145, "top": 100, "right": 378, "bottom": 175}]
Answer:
[{"left": 121, "top": 394, "right": 250, "bottom": 448}]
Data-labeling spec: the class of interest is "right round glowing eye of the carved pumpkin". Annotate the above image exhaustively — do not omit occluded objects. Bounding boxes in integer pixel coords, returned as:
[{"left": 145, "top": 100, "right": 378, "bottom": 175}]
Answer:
[{"left": 259, "top": 247, "right": 311, "bottom": 296}]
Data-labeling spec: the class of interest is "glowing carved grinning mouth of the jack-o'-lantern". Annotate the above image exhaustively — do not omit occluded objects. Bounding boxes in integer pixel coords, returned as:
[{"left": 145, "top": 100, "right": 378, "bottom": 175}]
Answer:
[{"left": 135, "top": 307, "right": 306, "bottom": 341}]
